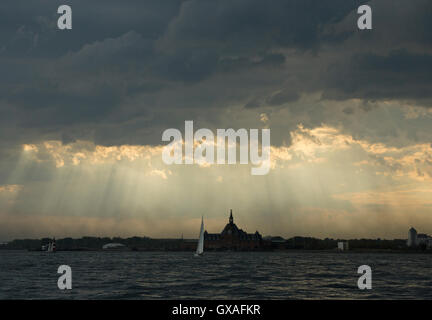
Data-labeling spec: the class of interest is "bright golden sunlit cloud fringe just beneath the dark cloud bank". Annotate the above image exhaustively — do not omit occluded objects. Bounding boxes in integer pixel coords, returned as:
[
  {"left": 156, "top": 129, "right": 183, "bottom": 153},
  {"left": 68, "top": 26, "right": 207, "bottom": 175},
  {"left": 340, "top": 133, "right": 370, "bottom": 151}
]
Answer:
[{"left": 19, "top": 125, "right": 432, "bottom": 185}]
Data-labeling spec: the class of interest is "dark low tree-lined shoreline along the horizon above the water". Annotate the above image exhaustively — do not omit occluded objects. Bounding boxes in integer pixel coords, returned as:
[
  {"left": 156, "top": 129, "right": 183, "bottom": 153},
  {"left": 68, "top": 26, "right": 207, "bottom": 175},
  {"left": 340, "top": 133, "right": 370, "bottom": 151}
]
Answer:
[{"left": 0, "top": 237, "right": 432, "bottom": 253}]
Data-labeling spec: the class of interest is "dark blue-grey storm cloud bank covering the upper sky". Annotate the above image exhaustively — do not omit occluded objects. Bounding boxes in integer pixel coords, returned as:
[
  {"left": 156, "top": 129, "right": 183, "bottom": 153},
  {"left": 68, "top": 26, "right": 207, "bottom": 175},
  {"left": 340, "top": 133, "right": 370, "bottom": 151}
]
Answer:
[{"left": 0, "top": 0, "right": 432, "bottom": 155}]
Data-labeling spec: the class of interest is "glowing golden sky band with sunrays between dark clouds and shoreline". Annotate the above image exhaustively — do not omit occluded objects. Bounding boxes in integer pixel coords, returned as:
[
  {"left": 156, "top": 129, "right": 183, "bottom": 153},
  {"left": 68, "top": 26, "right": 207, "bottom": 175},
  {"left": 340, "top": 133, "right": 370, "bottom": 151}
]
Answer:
[{"left": 6, "top": 125, "right": 432, "bottom": 241}]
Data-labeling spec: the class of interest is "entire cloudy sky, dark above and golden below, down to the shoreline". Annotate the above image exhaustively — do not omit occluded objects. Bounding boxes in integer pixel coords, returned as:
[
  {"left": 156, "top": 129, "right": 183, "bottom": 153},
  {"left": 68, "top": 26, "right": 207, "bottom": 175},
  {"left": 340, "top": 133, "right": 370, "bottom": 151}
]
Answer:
[{"left": 0, "top": 0, "right": 432, "bottom": 240}]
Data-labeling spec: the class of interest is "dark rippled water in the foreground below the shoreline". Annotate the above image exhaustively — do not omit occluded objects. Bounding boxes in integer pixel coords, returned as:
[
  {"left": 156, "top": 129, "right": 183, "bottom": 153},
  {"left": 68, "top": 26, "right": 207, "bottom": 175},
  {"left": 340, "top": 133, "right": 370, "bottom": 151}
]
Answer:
[{"left": 0, "top": 251, "right": 432, "bottom": 299}]
